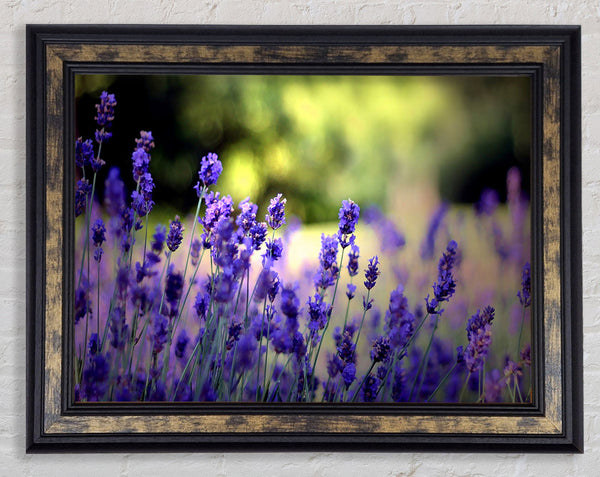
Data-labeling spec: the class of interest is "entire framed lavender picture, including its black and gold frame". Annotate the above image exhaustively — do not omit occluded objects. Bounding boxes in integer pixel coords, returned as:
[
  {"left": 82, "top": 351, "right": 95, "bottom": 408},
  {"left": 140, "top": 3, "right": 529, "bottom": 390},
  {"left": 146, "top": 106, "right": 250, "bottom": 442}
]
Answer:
[{"left": 27, "top": 25, "right": 583, "bottom": 452}]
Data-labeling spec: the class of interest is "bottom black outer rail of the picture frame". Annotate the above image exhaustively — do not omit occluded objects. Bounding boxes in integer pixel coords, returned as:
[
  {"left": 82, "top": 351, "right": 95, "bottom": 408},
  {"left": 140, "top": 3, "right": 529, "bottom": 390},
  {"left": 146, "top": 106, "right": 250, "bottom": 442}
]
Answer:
[{"left": 28, "top": 433, "right": 574, "bottom": 453}]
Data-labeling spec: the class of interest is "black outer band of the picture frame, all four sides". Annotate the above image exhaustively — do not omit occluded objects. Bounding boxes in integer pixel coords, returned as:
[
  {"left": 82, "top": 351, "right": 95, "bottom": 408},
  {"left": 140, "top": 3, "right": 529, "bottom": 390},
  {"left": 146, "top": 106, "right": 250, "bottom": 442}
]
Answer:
[{"left": 27, "top": 25, "right": 583, "bottom": 452}]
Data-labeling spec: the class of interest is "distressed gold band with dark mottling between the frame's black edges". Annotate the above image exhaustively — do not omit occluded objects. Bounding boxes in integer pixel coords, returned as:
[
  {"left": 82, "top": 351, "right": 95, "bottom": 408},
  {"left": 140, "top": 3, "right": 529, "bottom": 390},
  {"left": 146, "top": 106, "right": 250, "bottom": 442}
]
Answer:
[{"left": 40, "top": 43, "right": 563, "bottom": 436}]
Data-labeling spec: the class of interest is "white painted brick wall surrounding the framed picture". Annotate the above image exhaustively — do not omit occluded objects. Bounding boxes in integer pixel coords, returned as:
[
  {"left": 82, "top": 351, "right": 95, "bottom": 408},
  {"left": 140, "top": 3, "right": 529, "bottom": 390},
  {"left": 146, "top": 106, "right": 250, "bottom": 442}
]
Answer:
[{"left": 0, "top": 0, "right": 600, "bottom": 477}]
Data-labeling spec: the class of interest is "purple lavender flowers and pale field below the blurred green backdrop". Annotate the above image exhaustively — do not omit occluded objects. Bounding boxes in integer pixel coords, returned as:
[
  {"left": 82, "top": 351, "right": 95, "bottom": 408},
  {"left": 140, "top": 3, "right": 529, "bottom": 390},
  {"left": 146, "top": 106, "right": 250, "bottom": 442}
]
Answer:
[{"left": 73, "top": 92, "right": 535, "bottom": 403}]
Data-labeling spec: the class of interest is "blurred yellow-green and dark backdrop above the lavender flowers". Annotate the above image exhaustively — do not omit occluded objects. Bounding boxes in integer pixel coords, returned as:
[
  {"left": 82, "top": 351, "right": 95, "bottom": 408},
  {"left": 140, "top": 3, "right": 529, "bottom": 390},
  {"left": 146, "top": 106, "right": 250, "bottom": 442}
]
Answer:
[{"left": 76, "top": 75, "right": 531, "bottom": 223}]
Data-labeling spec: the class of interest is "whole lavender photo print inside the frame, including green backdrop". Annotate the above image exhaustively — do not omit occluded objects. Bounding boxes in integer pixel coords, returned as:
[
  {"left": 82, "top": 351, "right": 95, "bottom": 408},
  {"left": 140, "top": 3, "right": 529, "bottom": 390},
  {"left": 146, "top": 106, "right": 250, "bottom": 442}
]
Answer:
[{"left": 74, "top": 75, "right": 532, "bottom": 403}]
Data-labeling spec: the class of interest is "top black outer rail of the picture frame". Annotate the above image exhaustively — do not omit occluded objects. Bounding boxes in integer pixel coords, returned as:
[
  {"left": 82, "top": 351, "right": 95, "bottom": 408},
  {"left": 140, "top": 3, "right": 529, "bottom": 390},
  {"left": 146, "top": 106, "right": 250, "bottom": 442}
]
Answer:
[{"left": 24, "top": 24, "right": 572, "bottom": 45}]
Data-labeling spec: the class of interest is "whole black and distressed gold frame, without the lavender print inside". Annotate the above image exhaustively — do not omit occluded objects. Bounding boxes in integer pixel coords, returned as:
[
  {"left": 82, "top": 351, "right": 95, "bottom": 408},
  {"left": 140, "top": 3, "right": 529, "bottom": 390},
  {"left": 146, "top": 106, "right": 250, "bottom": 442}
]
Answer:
[{"left": 26, "top": 25, "right": 583, "bottom": 453}]
